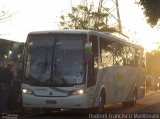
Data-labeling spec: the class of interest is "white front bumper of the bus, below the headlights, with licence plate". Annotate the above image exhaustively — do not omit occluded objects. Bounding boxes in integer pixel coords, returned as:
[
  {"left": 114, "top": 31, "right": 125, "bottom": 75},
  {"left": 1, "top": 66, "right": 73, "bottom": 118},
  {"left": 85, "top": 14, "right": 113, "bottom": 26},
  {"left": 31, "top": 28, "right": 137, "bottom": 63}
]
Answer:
[{"left": 22, "top": 94, "right": 91, "bottom": 109}]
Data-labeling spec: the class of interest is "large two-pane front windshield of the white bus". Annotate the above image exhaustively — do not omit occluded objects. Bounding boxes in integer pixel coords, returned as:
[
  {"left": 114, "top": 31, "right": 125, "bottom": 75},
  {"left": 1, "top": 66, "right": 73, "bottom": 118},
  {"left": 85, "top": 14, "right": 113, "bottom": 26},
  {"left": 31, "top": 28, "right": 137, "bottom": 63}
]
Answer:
[{"left": 25, "top": 34, "right": 86, "bottom": 85}]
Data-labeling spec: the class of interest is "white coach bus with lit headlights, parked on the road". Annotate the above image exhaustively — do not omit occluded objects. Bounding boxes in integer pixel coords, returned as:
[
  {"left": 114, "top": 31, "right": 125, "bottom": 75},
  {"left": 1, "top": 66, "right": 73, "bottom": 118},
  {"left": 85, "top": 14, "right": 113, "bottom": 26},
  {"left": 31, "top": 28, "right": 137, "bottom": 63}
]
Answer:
[{"left": 21, "top": 30, "right": 146, "bottom": 112}]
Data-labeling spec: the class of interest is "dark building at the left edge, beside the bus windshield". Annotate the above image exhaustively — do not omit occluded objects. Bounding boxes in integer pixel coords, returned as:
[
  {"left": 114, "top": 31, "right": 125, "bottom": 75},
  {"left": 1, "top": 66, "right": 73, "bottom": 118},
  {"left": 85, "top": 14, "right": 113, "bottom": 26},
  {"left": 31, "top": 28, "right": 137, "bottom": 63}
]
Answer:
[{"left": 0, "top": 38, "right": 24, "bottom": 78}]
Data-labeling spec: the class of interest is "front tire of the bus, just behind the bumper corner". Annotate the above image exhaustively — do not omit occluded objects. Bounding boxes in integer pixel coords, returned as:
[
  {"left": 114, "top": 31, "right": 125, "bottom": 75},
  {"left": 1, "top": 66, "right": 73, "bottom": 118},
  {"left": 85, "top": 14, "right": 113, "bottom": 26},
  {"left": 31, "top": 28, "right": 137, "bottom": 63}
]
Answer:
[{"left": 98, "top": 90, "right": 106, "bottom": 113}]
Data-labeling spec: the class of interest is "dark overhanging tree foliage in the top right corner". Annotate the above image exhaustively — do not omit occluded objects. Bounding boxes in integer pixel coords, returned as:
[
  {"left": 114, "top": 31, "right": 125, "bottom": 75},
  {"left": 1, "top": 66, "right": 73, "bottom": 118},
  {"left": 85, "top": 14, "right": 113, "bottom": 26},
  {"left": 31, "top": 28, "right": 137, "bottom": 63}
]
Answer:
[{"left": 138, "top": 0, "right": 160, "bottom": 27}]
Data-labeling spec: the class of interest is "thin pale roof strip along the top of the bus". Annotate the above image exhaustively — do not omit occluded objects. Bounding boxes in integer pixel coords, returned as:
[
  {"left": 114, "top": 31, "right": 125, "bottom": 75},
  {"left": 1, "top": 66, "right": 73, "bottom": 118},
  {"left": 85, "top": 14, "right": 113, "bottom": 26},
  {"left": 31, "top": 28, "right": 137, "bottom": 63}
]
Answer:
[{"left": 28, "top": 29, "right": 144, "bottom": 49}]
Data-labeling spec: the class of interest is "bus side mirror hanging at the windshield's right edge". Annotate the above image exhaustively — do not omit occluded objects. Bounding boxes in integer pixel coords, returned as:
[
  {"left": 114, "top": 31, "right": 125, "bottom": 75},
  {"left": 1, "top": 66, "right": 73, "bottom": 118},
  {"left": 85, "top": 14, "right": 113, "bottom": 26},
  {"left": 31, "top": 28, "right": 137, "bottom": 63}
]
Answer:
[{"left": 84, "top": 42, "right": 92, "bottom": 61}]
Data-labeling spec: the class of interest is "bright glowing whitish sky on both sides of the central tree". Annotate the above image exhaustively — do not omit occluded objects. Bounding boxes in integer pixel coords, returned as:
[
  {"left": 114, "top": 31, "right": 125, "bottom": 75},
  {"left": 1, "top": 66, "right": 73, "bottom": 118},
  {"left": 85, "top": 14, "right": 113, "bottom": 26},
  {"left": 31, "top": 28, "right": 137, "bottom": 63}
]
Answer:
[{"left": 0, "top": 0, "right": 160, "bottom": 50}]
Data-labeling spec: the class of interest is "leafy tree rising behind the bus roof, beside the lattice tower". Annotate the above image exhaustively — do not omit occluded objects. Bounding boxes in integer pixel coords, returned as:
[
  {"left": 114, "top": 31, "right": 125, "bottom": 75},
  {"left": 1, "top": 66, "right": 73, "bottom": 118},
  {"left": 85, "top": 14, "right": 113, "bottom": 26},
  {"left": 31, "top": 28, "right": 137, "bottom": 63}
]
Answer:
[{"left": 59, "top": 0, "right": 116, "bottom": 32}]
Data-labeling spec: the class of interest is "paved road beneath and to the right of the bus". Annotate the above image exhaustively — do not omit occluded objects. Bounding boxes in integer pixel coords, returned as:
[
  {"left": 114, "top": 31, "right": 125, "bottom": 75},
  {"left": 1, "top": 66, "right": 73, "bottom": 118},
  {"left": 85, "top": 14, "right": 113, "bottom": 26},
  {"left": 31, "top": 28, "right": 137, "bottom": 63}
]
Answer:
[{"left": 2, "top": 91, "right": 160, "bottom": 119}]
